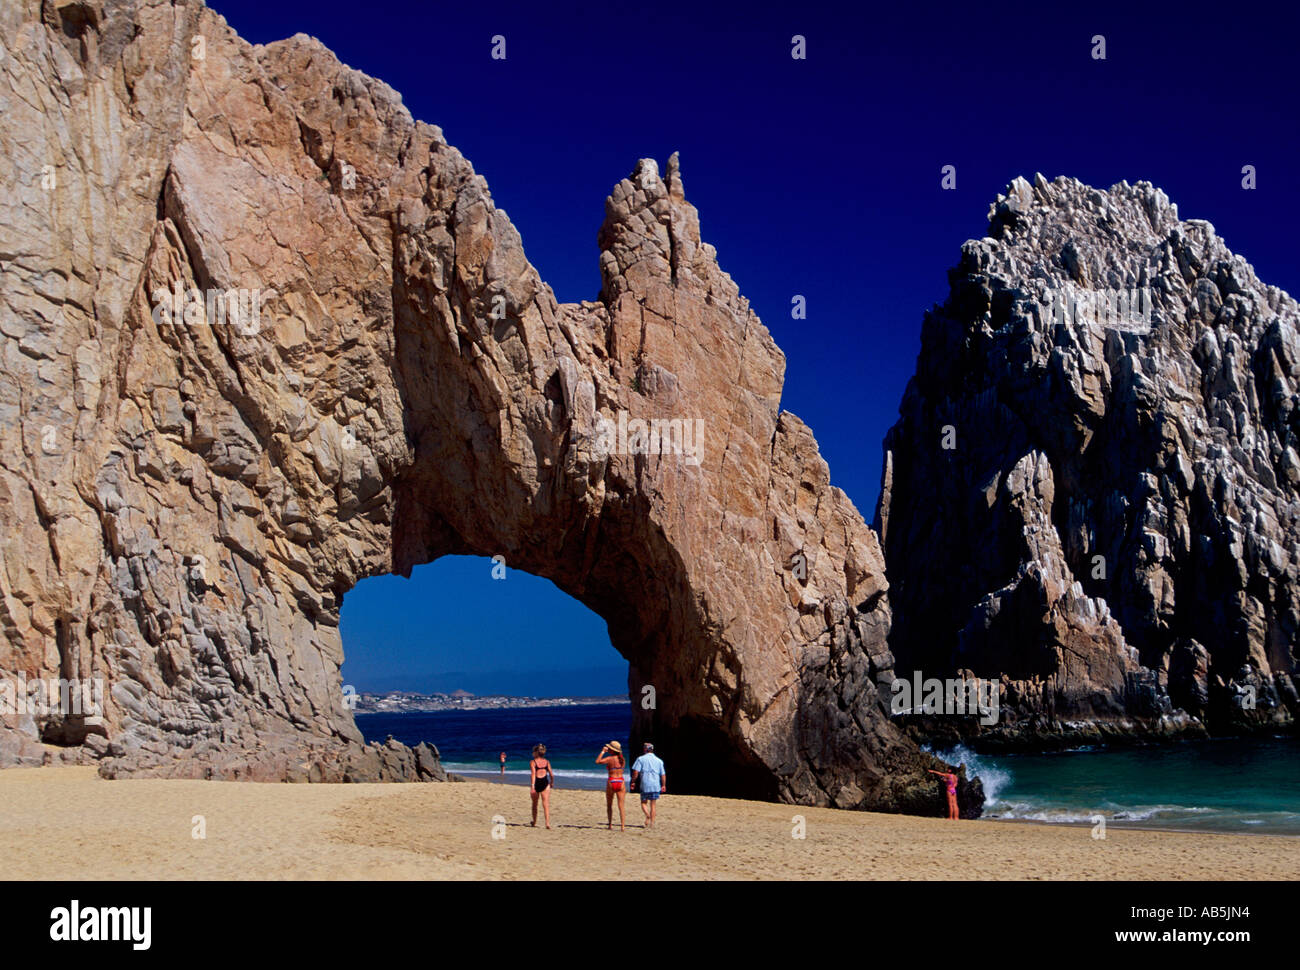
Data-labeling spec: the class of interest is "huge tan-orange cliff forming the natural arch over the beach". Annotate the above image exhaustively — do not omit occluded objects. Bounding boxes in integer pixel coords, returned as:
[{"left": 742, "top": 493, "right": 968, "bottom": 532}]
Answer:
[{"left": 0, "top": 0, "right": 980, "bottom": 813}]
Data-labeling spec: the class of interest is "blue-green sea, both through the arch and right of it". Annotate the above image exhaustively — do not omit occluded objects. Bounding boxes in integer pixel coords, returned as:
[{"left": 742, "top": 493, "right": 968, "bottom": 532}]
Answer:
[{"left": 356, "top": 703, "right": 1300, "bottom": 836}]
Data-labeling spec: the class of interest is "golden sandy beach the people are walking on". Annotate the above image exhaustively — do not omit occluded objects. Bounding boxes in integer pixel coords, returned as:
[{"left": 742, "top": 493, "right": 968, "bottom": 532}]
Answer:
[{"left": 0, "top": 767, "right": 1300, "bottom": 880}]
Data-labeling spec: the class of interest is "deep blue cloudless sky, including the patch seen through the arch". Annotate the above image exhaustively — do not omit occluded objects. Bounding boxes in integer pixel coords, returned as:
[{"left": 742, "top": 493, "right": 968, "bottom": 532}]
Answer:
[{"left": 202, "top": 0, "right": 1300, "bottom": 692}]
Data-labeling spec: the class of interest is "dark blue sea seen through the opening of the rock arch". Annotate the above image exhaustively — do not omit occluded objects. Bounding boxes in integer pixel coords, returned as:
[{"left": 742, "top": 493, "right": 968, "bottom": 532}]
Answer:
[{"left": 356, "top": 703, "right": 633, "bottom": 789}]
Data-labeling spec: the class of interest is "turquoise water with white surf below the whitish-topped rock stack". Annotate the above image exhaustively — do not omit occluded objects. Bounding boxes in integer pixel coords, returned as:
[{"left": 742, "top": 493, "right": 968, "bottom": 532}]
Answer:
[{"left": 936, "top": 737, "right": 1300, "bottom": 835}]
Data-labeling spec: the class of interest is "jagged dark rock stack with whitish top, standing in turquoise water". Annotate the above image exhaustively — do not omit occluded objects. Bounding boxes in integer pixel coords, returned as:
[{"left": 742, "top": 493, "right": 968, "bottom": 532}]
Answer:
[{"left": 876, "top": 176, "right": 1300, "bottom": 744}]
